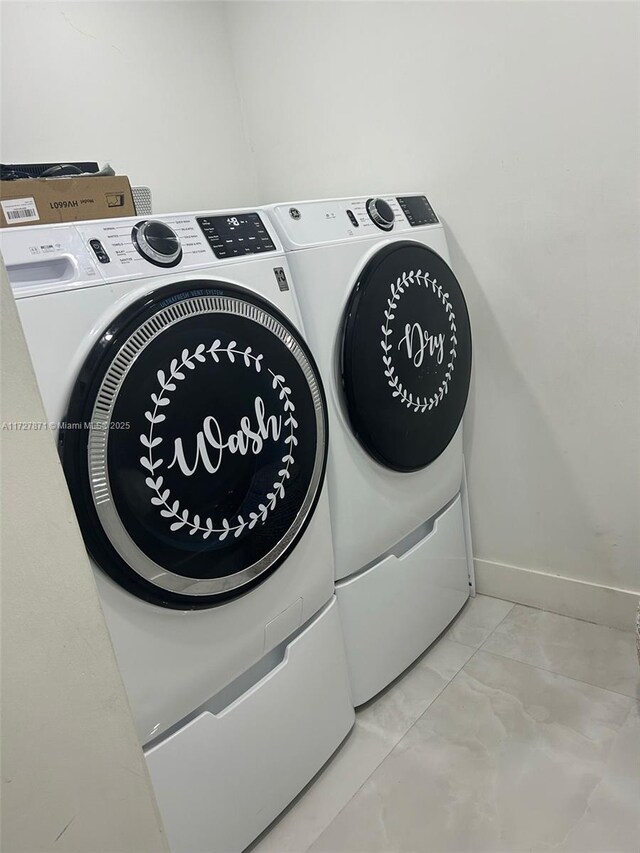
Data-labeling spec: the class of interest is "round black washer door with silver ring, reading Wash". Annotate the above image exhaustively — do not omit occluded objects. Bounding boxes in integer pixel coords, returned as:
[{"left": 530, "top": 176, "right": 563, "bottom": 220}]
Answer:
[{"left": 61, "top": 281, "right": 327, "bottom": 608}]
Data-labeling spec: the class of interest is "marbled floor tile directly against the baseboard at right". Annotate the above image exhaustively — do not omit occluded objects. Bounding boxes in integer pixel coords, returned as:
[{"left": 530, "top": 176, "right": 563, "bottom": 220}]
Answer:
[{"left": 482, "top": 604, "right": 640, "bottom": 698}]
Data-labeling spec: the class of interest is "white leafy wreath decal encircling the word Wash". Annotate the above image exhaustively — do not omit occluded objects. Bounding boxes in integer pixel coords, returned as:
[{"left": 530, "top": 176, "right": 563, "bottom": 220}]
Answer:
[{"left": 140, "top": 339, "right": 298, "bottom": 542}]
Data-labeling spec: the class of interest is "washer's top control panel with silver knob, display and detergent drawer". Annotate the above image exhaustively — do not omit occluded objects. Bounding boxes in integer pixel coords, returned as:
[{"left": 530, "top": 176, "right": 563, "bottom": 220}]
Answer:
[{"left": 0, "top": 210, "right": 288, "bottom": 298}]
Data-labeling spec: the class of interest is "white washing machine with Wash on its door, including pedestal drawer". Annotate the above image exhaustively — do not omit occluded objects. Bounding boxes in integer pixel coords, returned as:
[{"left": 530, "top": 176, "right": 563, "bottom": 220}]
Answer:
[{"left": 0, "top": 210, "right": 354, "bottom": 853}]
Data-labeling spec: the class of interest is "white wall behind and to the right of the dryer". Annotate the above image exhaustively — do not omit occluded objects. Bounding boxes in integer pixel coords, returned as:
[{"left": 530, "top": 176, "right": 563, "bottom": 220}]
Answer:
[{"left": 228, "top": 2, "right": 640, "bottom": 615}]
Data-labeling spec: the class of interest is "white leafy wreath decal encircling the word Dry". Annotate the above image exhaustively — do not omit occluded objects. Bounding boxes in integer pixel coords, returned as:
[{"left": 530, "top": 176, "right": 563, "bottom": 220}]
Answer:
[{"left": 380, "top": 270, "right": 458, "bottom": 412}]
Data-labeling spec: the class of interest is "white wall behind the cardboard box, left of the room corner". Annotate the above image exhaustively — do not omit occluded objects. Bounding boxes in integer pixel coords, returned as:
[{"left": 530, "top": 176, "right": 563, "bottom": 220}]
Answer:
[{"left": 0, "top": 2, "right": 256, "bottom": 212}]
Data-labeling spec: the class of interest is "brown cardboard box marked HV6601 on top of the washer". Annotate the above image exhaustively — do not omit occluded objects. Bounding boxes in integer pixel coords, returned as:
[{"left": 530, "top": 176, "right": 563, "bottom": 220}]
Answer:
[{"left": 0, "top": 175, "right": 136, "bottom": 228}]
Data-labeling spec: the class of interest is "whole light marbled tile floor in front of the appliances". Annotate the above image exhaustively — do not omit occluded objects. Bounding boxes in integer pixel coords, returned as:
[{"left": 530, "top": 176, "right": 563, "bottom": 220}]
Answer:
[{"left": 251, "top": 596, "right": 640, "bottom": 853}]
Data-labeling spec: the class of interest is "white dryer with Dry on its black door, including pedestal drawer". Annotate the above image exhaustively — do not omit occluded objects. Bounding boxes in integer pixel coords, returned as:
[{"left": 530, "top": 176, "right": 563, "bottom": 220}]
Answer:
[{"left": 269, "top": 194, "right": 474, "bottom": 705}]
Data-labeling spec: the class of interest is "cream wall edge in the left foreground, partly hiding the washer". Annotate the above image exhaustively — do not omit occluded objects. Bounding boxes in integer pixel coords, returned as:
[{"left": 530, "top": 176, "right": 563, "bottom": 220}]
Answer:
[{"left": 0, "top": 262, "right": 169, "bottom": 853}]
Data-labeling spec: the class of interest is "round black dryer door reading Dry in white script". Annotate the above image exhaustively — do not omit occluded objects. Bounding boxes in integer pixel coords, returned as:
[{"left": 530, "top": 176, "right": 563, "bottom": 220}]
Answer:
[{"left": 341, "top": 241, "right": 471, "bottom": 471}]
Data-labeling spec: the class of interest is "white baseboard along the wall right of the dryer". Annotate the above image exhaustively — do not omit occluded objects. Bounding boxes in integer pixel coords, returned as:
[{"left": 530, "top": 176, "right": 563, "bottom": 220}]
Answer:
[{"left": 474, "top": 559, "right": 640, "bottom": 631}]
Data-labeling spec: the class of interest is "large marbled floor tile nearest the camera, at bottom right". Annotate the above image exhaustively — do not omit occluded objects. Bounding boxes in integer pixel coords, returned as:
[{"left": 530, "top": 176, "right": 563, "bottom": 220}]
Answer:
[{"left": 310, "top": 651, "right": 637, "bottom": 853}]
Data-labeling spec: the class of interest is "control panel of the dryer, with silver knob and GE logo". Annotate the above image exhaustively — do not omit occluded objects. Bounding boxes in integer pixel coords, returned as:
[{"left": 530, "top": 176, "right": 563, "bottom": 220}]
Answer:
[{"left": 269, "top": 193, "right": 440, "bottom": 249}]
